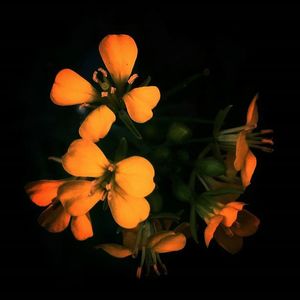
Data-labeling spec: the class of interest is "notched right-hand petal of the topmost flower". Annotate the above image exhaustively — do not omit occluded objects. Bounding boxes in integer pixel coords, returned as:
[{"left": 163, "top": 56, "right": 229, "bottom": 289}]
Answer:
[{"left": 123, "top": 86, "right": 160, "bottom": 123}]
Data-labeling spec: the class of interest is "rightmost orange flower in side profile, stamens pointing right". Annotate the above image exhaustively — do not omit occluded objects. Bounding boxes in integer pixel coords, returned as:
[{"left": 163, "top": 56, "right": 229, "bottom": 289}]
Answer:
[{"left": 217, "top": 95, "right": 273, "bottom": 187}]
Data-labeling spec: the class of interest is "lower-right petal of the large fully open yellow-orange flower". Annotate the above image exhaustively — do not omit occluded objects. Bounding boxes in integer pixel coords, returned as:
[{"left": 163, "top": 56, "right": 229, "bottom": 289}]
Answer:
[{"left": 108, "top": 189, "right": 150, "bottom": 228}]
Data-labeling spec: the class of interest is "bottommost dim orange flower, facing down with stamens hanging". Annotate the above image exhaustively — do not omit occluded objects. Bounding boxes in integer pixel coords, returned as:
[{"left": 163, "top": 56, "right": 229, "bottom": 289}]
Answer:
[{"left": 96, "top": 221, "right": 186, "bottom": 278}]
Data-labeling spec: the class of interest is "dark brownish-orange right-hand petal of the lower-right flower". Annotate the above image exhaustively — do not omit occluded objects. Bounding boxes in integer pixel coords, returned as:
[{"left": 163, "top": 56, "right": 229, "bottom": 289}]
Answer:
[{"left": 231, "top": 209, "right": 260, "bottom": 237}]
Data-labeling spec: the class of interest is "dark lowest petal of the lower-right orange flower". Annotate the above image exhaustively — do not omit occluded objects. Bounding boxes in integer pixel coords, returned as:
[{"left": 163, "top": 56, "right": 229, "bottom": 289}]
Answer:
[{"left": 214, "top": 227, "right": 243, "bottom": 254}]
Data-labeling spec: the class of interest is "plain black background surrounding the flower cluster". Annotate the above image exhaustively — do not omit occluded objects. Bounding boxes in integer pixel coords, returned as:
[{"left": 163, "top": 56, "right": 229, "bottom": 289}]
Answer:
[{"left": 0, "top": 3, "right": 300, "bottom": 293}]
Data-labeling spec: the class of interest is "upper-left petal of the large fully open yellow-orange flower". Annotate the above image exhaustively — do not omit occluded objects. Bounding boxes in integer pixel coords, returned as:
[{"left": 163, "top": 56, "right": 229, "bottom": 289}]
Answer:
[{"left": 62, "top": 139, "right": 109, "bottom": 177}]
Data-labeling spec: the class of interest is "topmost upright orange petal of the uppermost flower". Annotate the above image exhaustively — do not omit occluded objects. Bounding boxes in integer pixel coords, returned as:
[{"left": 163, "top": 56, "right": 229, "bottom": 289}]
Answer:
[{"left": 99, "top": 34, "right": 138, "bottom": 86}]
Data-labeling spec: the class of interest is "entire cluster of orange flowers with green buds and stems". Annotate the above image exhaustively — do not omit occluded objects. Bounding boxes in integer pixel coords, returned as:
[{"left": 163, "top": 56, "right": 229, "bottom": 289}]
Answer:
[{"left": 25, "top": 34, "right": 273, "bottom": 278}]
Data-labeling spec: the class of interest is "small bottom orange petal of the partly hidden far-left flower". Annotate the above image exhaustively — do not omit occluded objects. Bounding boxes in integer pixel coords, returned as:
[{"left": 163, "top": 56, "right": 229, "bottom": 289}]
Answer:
[{"left": 71, "top": 214, "right": 93, "bottom": 241}]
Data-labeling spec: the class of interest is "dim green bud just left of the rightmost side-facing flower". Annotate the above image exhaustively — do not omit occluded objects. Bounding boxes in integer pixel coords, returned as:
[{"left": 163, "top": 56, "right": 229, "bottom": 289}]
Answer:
[{"left": 196, "top": 157, "right": 226, "bottom": 176}]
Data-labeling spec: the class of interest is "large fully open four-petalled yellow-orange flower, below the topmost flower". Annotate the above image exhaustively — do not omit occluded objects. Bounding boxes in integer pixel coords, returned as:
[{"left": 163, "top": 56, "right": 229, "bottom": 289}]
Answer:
[{"left": 58, "top": 139, "right": 155, "bottom": 228}]
